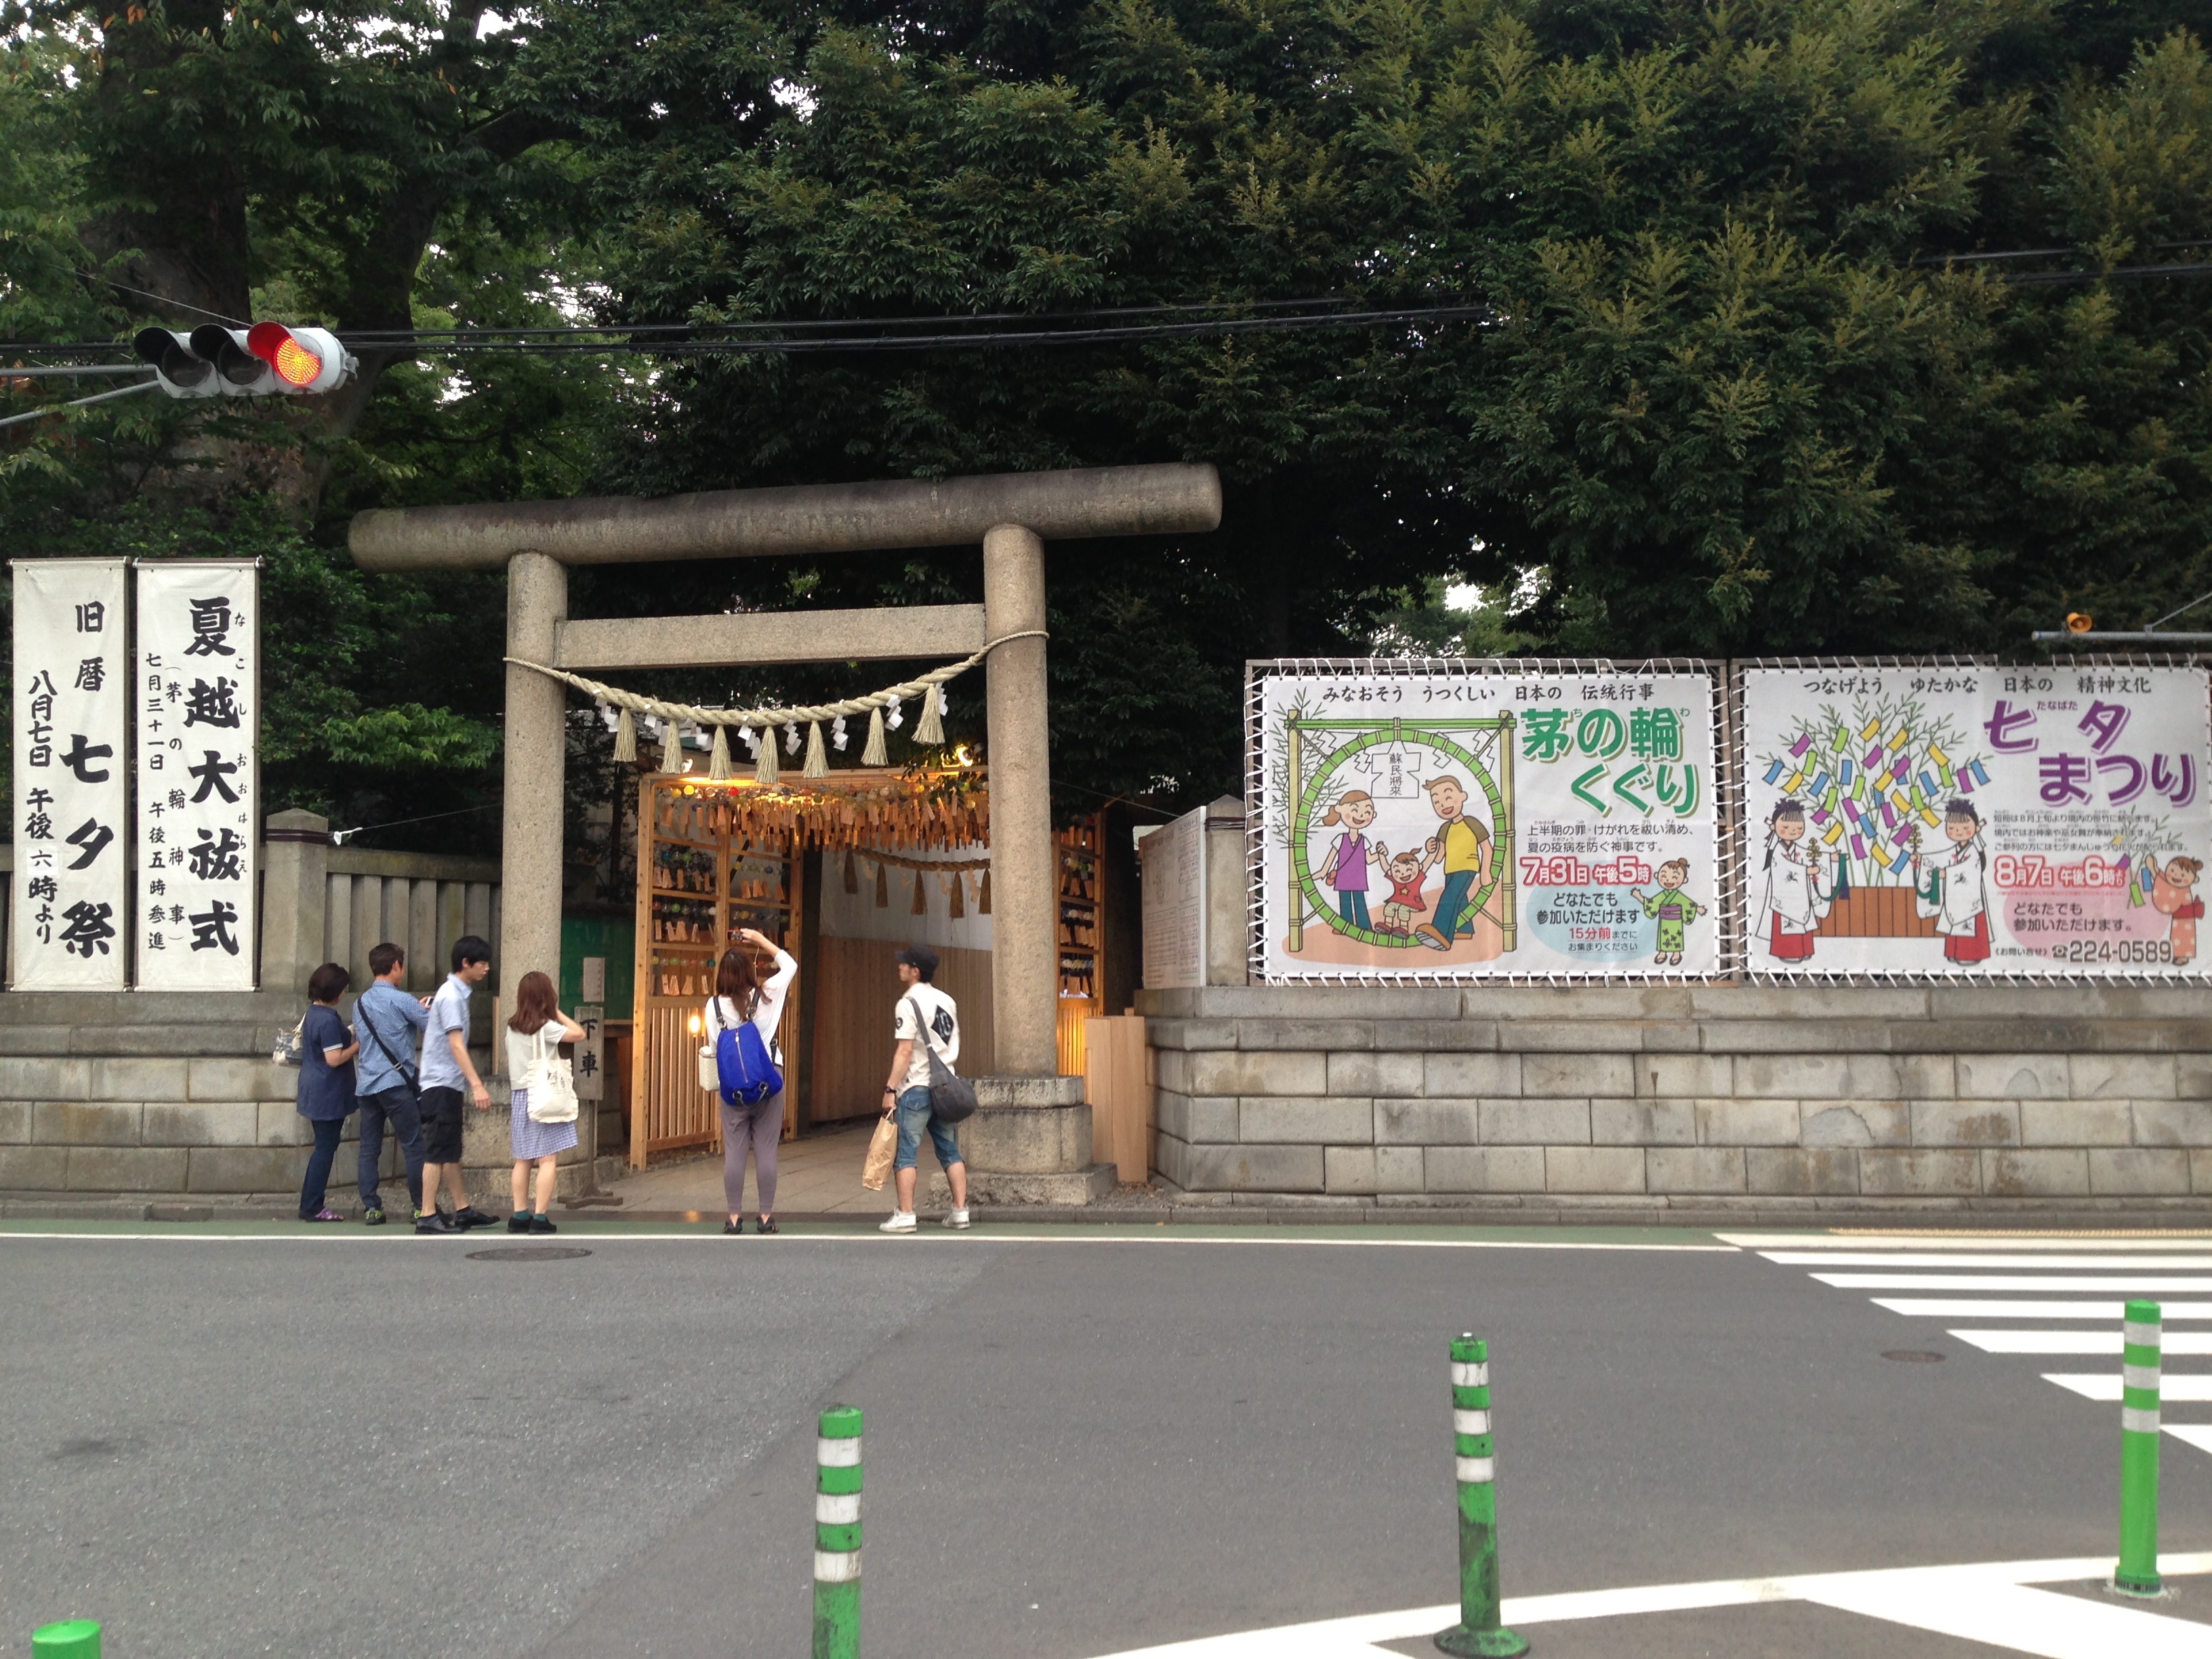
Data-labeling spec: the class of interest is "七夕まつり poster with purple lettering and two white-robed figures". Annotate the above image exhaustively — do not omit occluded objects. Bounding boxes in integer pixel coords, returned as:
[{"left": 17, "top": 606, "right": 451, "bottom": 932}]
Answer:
[{"left": 1743, "top": 663, "right": 2212, "bottom": 978}]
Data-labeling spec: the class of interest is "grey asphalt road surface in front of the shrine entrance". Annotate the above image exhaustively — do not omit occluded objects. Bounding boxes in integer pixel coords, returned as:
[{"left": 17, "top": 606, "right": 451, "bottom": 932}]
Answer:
[{"left": 0, "top": 1225, "right": 2212, "bottom": 1659}]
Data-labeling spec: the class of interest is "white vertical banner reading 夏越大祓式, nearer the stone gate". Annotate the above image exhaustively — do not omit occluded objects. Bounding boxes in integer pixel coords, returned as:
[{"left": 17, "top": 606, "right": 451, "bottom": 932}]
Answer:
[{"left": 133, "top": 560, "right": 261, "bottom": 991}]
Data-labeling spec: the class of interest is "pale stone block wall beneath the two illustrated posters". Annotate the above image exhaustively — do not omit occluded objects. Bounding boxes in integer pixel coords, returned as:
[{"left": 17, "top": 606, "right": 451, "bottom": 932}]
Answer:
[{"left": 1139, "top": 987, "right": 2212, "bottom": 1210}]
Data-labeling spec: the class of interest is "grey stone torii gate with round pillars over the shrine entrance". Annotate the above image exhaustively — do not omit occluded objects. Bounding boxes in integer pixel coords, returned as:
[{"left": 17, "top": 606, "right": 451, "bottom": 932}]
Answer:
[{"left": 350, "top": 464, "right": 1221, "bottom": 1124}]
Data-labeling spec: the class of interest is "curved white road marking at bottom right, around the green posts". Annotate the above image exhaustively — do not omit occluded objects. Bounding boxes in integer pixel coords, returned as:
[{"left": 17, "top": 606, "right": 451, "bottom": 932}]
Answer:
[{"left": 1075, "top": 1553, "right": 2212, "bottom": 1659}]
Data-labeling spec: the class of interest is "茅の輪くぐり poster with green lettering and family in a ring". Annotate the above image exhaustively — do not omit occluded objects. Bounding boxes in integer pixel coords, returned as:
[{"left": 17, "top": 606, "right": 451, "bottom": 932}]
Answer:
[{"left": 1254, "top": 661, "right": 1721, "bottom": 980}]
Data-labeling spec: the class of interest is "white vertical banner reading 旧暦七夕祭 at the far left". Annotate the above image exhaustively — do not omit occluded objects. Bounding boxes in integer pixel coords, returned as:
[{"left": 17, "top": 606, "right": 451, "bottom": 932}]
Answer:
[{"left": 14, "top": 560, "right": 131, "bottom": 991}]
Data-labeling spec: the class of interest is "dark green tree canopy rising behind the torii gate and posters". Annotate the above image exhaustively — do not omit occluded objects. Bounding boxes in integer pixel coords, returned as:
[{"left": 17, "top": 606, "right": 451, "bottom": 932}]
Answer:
[{"left": 0, "top": 0, "right": 2212, "bottom": 836}]
